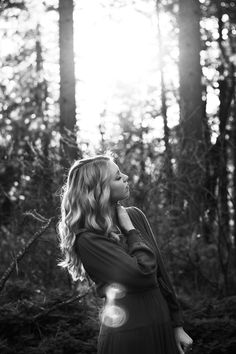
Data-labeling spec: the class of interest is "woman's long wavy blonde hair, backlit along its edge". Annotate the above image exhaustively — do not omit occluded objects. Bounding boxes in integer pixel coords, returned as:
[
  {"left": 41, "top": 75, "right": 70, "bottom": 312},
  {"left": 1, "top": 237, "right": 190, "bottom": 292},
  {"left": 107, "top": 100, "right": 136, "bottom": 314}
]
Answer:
[{"left": 58, "top": 155, "right": 118, "bottom": 281}]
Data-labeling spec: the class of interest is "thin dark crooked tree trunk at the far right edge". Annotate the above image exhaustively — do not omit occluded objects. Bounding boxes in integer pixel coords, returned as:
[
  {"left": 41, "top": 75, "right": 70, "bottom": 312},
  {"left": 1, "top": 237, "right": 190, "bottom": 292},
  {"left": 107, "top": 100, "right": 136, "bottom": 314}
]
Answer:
[{"left": 217, "top": 0, "right": 235, "bottom": 295}]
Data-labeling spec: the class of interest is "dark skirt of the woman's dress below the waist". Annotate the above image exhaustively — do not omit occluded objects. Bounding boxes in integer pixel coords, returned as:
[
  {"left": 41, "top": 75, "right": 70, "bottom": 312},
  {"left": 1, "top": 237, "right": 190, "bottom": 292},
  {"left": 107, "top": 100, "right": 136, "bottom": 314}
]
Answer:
[{"left": 98, "top": 287, "right": 179, "bottom": 354}]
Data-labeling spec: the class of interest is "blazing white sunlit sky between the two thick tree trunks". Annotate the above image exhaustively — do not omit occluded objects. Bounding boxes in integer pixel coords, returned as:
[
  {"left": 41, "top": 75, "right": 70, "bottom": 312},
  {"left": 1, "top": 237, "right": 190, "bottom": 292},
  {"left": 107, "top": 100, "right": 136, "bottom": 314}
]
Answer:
[{"left": 74, "top": 0, "right": 178, "bottom": 147}]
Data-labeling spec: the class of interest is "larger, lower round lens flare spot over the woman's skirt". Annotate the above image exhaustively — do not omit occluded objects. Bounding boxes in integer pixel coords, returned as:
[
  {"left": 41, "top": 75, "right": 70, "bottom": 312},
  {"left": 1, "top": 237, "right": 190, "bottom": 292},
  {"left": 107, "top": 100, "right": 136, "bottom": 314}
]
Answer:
[{"left": 101, "top": 305, "right": 127, "bottom": 328}]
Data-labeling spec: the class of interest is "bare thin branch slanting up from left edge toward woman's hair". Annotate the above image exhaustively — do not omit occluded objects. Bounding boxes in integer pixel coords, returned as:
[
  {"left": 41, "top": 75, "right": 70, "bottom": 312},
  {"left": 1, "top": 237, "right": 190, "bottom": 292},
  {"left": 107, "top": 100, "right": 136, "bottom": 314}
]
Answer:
[{"left": 0, "top": 217, "right": 54, "bottom": 292}]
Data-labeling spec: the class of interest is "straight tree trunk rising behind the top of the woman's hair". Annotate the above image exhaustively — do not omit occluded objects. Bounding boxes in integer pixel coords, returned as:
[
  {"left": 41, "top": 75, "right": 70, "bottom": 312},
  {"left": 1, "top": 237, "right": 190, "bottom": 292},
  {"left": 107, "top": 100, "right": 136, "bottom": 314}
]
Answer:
[{"left": 59, "top": 0, "right": 77, "bottom": 162}]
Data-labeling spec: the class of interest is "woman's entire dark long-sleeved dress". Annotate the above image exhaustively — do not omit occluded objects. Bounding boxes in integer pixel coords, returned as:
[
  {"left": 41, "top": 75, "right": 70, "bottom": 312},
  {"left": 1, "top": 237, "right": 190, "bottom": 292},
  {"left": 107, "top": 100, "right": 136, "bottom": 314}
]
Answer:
[{"left": 77, "top": 207, "right": 183, "bottom": 354}]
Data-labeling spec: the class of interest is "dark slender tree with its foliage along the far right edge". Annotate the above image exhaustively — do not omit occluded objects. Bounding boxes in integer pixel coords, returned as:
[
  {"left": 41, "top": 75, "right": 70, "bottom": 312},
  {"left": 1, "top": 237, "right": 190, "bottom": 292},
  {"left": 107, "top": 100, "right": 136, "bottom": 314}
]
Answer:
[{"left": 204, "top": 0, "right": 235, "bottom": 293}]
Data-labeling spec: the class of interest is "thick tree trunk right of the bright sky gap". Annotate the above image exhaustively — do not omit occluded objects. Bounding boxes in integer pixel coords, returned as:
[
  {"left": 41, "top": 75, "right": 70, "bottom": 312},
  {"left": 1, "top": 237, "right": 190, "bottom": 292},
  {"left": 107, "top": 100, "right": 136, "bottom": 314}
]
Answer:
[{"left": 178, "top": 0, "right": 205, "bottom": 228}]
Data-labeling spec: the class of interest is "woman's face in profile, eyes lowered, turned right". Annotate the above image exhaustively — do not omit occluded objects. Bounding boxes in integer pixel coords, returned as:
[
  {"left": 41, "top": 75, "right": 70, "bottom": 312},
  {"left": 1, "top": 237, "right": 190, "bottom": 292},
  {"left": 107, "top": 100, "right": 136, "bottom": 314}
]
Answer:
[{"left": 108, "top": 161, "right": 129, "bottom": 202}]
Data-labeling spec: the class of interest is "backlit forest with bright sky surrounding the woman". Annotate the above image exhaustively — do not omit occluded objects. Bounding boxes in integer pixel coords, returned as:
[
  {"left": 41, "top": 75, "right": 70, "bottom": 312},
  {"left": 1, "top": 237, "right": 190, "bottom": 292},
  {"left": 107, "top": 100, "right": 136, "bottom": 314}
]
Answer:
[{"left": 0, "top": 0, "right": 236, "bottom": 354}]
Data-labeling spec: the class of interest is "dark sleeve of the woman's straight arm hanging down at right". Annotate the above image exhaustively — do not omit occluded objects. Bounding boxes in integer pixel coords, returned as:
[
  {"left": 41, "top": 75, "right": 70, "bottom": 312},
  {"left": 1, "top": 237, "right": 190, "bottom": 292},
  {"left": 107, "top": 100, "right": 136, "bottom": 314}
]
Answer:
[{"left": 127, "top": 207, "right": 183, "bottom": 327}]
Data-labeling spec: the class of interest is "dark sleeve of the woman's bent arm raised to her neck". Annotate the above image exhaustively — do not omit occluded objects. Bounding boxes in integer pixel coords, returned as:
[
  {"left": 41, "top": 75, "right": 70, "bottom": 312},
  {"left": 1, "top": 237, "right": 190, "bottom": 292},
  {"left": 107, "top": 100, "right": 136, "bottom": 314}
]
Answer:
[{"left": 77, "top": 230, "right": 157, "bottom": 291}]
